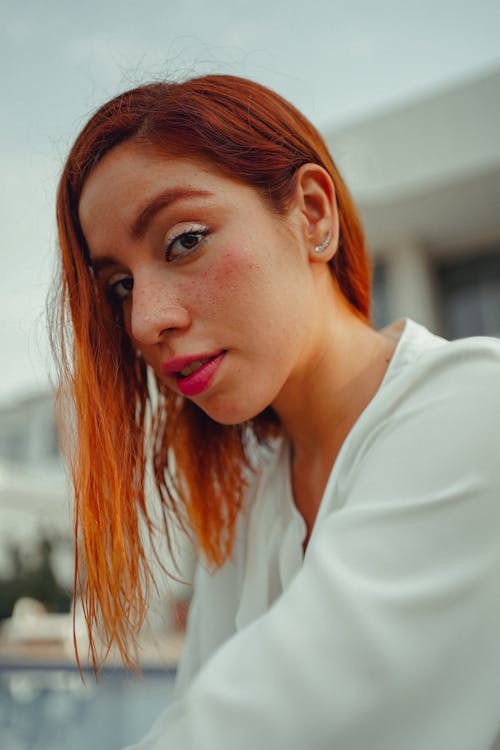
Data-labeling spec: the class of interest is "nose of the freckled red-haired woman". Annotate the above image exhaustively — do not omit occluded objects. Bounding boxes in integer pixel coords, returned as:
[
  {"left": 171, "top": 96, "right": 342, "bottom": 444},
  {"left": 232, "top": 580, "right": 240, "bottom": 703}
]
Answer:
[{"left": 129, "top": 278, "right": 191, "bottom": 347}]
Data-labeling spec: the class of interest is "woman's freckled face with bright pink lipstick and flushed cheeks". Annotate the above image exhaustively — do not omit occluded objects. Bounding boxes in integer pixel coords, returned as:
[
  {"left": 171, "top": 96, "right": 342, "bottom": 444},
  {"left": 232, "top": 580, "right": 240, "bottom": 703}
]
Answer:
[{"left": 79, "top": 141, "right": 324, "bottom": 424}]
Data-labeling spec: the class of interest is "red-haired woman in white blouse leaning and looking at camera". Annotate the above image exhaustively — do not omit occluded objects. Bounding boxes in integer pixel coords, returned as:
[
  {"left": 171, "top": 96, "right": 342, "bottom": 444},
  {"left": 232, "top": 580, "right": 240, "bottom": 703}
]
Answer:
[{"left": 53, "top": 76, "right": 500, "bottom": 750}]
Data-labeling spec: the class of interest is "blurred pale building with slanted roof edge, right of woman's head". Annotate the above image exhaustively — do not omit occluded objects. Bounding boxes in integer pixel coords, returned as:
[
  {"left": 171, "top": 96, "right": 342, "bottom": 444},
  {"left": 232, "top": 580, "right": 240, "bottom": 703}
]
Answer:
[{"left": 326, "top": 63, "right": 500, "bottom": 338}]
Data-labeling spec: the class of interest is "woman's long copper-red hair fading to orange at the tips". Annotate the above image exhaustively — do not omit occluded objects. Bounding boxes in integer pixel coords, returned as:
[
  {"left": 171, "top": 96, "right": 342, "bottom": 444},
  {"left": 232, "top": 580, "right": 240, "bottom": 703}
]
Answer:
[{"left": 52, "top": 75, "right": 370, "bottom": 667}]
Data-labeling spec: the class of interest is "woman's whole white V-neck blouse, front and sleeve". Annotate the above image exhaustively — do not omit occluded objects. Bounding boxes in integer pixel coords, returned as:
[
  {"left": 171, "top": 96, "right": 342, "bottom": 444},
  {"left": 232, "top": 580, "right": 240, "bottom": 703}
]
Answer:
[{"left": 127, "top": 321, "right": 500, "bottom": 750}]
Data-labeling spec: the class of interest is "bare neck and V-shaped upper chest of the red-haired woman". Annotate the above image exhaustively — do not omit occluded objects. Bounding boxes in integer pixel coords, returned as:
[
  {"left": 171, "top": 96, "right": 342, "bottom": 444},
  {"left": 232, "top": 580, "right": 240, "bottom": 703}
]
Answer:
[{"left": 273, "top": 296, "right": 395, "bottom": 533}]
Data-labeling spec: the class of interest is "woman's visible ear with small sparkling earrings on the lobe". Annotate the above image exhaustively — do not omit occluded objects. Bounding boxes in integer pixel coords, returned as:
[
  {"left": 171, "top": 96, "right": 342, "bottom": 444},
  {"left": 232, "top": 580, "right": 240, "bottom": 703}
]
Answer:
[{"left": 295, "top": 163, "right": 339, "bottom": 263}]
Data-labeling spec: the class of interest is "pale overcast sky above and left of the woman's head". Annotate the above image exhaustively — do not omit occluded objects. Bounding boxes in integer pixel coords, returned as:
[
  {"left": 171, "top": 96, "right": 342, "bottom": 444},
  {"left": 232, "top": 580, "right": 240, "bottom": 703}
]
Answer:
[{"left": 0, "top": 0, "right": 500, "bottom": 405}]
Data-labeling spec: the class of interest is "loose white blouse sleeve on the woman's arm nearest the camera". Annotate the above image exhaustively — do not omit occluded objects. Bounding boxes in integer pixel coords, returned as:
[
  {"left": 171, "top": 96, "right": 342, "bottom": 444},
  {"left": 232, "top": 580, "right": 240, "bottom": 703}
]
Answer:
[{"left": 126, "top": 348, "right": 500, "bottom": 750}]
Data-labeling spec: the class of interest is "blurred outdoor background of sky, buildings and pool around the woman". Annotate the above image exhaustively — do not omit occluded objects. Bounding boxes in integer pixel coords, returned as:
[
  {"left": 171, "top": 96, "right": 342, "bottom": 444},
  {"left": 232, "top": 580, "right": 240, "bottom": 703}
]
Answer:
[{"left": 0, "top": 0, "right": 500, "bottom": 750}]
